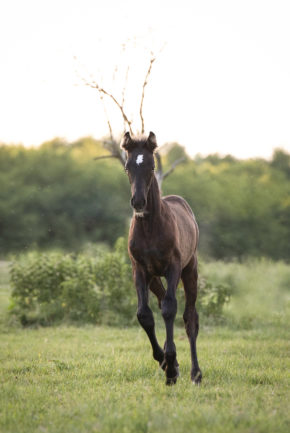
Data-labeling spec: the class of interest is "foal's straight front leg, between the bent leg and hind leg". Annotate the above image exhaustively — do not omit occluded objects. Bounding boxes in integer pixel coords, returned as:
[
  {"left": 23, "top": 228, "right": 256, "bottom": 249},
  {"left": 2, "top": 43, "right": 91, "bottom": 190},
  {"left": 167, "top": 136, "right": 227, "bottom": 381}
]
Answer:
[{"left": 161, "top": 264, "right": 181, "bottom": 385}]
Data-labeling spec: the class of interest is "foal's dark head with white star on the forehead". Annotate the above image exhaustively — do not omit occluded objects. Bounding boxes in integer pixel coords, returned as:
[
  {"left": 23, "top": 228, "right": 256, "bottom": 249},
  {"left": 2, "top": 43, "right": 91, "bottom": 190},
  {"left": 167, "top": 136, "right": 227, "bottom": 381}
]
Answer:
[{"left": 121, "top": 132, "right": 157, "bottom": 216}]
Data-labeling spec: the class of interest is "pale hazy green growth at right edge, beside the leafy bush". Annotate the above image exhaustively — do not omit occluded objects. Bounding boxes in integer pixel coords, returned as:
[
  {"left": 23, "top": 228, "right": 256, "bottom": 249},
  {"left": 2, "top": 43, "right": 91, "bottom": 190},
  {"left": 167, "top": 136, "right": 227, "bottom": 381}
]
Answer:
[{"left": 202, "top": 258, "right": 290, "bottom": 329}]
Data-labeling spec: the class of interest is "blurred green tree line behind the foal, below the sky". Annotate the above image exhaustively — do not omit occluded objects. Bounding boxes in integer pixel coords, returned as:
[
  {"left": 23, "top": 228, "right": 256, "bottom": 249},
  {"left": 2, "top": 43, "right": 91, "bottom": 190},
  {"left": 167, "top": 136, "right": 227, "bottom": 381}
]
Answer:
[{"left": 0, "top": 138, "right": 290, "bottom": 260}]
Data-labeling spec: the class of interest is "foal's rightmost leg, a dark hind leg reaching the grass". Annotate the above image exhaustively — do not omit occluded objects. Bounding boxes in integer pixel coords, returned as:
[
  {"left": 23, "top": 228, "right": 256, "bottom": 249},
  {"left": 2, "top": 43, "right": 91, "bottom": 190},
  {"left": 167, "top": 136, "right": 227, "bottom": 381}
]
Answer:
[{"left": 181, "top": 259, "right": 202, "bottom": 384}]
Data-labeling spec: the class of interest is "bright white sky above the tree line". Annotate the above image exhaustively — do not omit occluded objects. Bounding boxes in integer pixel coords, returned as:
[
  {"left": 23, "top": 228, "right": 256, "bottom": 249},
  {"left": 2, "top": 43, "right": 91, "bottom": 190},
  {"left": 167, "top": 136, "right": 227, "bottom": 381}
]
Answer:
[{"left": 0, "top": 0, "right": 290, "bottom": 158}]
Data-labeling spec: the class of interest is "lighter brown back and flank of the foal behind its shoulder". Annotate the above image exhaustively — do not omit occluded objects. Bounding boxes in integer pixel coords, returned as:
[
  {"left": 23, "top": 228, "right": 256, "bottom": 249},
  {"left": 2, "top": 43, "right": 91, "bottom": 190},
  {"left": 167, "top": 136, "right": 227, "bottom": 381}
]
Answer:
[{"left": 162, "top": 195, "right": 199, "bottom": 266}]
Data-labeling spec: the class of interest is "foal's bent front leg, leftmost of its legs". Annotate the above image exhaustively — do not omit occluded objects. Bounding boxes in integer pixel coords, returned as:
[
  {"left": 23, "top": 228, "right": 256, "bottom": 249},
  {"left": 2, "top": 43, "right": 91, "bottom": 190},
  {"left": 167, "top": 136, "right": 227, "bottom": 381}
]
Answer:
[{"left": 133, "top": 267, "right": 164, "bottom": 366}]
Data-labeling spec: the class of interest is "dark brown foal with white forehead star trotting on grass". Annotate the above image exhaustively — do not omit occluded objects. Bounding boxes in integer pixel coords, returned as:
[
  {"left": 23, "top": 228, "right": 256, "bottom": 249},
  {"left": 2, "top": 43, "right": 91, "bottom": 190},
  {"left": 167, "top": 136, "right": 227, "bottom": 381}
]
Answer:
[{"left": 121, "top": 132, "right": 202, "bottom": 385}]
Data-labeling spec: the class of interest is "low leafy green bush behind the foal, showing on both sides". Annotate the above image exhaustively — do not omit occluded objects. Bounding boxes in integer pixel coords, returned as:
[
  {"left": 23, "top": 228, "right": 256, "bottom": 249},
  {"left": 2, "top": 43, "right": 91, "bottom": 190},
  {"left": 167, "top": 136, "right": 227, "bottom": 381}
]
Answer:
[{"left": 11, "top": 238, "right": 230, "bottom": 325}]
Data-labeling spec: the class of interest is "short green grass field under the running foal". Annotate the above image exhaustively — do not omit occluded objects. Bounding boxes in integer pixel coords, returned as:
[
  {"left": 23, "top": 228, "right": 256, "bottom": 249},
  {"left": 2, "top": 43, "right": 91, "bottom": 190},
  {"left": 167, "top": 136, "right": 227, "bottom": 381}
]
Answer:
[{"left": 0, "top": 264, "right": 290, "bottom": 433}]
